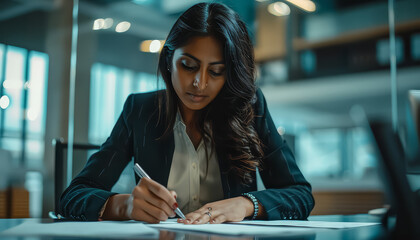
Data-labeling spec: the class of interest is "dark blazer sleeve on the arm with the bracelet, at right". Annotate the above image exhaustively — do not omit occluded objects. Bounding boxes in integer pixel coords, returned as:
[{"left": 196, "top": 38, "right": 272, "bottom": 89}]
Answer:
[{"left": 251, "top": 89, "right": 314, "bottom": 220}]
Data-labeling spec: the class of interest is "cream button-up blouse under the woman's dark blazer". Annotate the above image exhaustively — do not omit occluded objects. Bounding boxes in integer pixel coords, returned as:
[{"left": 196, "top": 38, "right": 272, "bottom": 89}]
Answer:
[{"left": 168, "top": 111, "right": 223, "bottom": 214}]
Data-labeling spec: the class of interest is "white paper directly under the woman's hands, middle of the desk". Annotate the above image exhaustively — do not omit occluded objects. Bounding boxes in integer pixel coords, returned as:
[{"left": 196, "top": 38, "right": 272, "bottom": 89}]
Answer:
[{"left": 148, "top": 221, "right": 315, "bottom": 236}]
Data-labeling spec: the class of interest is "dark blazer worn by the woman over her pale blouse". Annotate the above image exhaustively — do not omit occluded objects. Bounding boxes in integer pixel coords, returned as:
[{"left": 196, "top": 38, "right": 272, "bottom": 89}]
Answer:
[{"left": 59, "top": 89, "right": 314, "bottom": 220}]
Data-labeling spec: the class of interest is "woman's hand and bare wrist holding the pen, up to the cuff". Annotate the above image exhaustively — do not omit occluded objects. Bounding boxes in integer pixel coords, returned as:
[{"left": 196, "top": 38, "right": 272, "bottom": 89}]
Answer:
[{"left": 102, "top": 178, "right": 178, "bottom": 223}]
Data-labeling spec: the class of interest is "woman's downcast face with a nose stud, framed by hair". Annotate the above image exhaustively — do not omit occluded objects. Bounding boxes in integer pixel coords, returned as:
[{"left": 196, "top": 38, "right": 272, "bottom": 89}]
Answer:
[{"left": 171, "top": 36, "right": 226, "bottom": 110}]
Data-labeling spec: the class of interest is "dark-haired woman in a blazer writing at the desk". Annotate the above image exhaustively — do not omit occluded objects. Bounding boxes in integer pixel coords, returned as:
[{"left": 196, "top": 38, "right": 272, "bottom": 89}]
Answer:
[{"left": 60, "top": 3, "right": 314, "bottom": 224}]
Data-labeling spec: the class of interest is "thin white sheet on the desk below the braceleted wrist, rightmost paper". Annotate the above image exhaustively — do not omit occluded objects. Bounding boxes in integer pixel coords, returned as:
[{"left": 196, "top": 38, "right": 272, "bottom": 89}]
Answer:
[{"left": 232, "top": 220, "right": 379, "bottom": 229}]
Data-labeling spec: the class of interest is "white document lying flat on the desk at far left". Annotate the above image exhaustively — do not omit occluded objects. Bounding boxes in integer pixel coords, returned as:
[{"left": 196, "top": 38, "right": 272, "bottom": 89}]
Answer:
[{"left": 0, "top": 220, "right": 159, "bottom": 239}]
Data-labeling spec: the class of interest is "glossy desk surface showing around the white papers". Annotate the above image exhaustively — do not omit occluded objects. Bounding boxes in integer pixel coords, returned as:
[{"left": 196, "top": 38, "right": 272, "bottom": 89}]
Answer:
[{"left": 0, "top": 214, "right": 387, "bottom": 240}]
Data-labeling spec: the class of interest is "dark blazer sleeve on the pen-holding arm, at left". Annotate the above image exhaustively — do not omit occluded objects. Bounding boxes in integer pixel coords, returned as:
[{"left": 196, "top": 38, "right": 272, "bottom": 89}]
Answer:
[{"left": 59, "top": 95, "right": 134, "bottom": 220}]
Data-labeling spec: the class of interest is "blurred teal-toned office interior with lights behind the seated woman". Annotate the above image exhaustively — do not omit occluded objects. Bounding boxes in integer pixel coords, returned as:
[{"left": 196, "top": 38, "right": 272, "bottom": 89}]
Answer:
[{"left": 0, "top": 0, "right": 420, "bottom": 217}]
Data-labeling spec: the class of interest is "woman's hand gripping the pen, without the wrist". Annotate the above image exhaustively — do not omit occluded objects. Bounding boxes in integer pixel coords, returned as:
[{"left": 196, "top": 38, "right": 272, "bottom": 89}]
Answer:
[{"left": 126, "top": 178, "right": 178, "bottom": 223}]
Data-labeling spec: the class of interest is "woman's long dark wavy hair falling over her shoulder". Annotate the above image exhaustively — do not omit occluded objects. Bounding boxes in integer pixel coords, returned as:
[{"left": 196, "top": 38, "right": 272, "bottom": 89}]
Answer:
[{"left": 158, "top": 3, "right": 263, "bottom": 184}]
